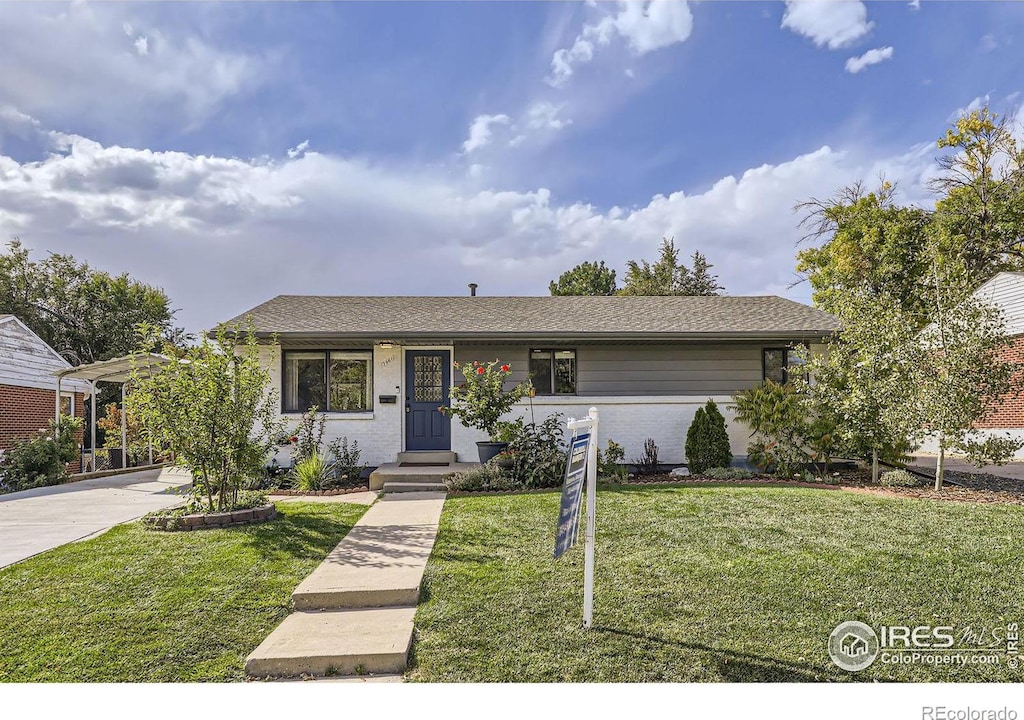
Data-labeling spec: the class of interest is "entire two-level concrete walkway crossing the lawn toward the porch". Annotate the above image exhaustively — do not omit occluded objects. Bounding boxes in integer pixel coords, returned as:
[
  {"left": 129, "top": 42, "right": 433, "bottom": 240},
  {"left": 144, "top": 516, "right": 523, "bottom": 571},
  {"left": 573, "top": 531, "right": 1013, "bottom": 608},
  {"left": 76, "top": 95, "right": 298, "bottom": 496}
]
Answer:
[{"left": 246, "top": 493, "right": 444, "bottom": 677}]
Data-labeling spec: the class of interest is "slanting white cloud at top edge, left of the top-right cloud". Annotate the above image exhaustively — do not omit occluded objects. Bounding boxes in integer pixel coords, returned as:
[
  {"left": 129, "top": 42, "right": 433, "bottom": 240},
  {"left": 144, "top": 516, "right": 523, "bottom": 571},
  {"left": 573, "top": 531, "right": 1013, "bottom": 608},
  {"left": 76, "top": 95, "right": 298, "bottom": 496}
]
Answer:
[{"left": 547, "top": 0, "right": 693, "bottom": 87}]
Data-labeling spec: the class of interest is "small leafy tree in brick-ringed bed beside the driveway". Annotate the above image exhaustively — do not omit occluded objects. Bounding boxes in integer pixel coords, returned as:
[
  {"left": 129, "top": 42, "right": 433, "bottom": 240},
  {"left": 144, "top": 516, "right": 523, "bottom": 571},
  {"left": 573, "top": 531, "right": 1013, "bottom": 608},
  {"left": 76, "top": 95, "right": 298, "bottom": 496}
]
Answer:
[{"left": 128, "top": 328, "right": 282, "bottom": 512}]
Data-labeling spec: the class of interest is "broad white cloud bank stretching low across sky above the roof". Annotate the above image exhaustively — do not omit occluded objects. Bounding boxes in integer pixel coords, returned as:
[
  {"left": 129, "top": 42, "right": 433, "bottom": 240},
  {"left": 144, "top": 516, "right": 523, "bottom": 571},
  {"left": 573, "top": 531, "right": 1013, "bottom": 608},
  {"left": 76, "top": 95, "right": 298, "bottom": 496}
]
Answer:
[{"left": 0, "top": 112, "right": 950, "bottom": 330}]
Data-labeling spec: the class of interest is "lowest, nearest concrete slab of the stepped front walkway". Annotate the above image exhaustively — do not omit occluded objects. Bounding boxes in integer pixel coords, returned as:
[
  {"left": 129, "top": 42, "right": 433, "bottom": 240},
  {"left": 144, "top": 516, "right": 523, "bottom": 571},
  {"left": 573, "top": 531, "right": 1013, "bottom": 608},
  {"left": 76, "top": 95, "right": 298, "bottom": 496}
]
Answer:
[{"left": 246, "top": 607, "right": 416, "bottom": 677}]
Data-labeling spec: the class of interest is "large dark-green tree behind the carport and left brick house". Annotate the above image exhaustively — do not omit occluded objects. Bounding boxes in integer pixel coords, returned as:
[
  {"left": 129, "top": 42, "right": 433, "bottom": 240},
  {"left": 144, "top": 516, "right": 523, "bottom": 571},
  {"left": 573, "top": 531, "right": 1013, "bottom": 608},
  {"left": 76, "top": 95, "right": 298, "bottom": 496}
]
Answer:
[{"left": 0, "top": 239, "right": 182, "bottom": 365}]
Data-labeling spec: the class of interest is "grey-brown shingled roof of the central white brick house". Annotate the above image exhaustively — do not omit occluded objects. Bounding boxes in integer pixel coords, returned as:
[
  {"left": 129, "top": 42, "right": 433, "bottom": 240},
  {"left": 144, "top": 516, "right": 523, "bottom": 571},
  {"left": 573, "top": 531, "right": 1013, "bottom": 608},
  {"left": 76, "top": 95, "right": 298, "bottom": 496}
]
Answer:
[{"left": 218, "top": 295, "right": 839, "bottom": 340}]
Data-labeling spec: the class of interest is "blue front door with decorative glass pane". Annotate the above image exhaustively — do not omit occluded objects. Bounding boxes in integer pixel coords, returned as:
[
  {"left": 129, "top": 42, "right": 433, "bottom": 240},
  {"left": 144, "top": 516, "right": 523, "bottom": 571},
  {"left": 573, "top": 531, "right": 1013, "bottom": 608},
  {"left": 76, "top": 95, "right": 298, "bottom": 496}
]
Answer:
[{"left": 406, "top": 350, "right": 452, "bottom": 450}]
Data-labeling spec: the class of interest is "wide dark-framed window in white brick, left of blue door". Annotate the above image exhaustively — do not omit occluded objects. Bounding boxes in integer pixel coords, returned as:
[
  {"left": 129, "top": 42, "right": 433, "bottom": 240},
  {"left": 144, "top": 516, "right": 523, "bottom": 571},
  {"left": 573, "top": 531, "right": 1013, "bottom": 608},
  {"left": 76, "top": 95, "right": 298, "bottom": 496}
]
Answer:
[{"left": 282, "top": 350, "right": 373, "bottom": 413}]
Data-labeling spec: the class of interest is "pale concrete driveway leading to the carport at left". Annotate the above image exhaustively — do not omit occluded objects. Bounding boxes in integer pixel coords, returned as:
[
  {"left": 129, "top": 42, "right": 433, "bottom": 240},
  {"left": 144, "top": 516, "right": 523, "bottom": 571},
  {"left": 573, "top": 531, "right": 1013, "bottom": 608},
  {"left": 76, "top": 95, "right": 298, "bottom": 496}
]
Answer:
[{"left": 0, "top": 467, "right": 191, "bottom": 567}]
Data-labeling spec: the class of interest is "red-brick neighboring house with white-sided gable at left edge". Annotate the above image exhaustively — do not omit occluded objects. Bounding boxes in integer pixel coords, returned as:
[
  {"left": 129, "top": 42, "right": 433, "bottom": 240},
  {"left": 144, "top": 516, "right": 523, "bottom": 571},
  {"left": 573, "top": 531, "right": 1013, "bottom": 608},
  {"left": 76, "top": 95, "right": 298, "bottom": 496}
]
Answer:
[{"left": 0, "top": 314, "right": 90, "bottom": 472}]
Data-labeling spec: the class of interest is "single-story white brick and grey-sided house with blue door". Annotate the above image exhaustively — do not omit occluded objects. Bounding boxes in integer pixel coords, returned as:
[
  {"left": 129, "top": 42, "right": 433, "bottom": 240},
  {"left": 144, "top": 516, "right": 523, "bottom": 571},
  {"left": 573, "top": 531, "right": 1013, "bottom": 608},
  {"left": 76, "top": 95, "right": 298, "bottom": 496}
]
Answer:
[{"left": 226, "top": 295, "right": 839, "bottom": 465}]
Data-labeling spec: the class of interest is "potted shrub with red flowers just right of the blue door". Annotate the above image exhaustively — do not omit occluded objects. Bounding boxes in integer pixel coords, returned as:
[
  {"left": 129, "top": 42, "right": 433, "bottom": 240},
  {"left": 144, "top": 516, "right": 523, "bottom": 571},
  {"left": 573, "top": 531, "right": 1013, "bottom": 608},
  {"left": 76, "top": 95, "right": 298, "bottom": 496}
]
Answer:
[{"left": 438, "top": 359, "right": 530, "bottom": 463}]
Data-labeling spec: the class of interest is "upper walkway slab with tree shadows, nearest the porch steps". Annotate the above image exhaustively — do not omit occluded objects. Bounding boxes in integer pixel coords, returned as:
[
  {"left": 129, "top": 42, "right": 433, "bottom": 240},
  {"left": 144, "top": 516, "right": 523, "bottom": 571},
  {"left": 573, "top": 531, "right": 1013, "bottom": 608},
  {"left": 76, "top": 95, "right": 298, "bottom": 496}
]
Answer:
[{"left": 292, "top": 493, "right": 444, "bottom": 610}]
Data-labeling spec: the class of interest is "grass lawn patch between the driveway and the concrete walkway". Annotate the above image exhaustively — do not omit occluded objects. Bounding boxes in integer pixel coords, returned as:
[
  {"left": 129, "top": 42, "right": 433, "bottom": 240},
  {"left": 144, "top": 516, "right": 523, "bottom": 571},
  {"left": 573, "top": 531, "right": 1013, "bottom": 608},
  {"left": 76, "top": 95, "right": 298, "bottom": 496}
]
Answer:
[{"left": 0, "top": 502, "right": 366, "bottom": 682}]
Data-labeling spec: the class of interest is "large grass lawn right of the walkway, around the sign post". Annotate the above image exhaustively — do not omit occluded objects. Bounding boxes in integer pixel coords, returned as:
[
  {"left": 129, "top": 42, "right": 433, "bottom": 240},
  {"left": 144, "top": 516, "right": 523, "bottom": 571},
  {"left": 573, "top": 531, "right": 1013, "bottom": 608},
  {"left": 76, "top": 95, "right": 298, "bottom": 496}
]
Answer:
[{"left": 409, "top": 486, "right": 1024, "bottom": 682}]
